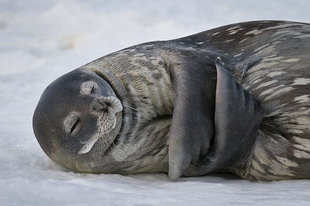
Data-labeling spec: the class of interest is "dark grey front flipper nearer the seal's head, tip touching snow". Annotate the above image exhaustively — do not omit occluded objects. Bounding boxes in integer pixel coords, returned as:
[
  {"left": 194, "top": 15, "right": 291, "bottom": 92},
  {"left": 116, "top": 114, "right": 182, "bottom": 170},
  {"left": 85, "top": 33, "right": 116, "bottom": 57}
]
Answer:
[{"left": 169, "top": 57, "right": 216, "bottom": 179}]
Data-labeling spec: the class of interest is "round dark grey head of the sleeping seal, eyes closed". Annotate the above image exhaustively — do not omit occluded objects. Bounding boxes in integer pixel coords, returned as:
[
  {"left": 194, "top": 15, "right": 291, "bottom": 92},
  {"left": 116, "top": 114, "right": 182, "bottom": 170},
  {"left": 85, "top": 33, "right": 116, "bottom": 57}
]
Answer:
[{"left": 33, "top": 69, "right": 123, "bottom": 172}]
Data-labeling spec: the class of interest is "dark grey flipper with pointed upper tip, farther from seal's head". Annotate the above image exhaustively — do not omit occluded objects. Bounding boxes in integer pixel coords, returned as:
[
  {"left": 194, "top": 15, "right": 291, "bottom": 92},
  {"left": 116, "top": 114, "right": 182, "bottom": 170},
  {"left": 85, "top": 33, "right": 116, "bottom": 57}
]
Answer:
[{"left": 203, "top": 58, "right": 263, "bottom": 171}]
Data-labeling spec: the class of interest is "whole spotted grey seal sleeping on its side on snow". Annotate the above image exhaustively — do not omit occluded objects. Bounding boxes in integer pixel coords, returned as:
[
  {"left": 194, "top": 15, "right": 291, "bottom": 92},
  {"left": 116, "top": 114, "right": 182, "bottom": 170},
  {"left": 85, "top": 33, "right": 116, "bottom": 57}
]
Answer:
[{"left": 33, "top": 21, "right": 310, "bottom": 180}]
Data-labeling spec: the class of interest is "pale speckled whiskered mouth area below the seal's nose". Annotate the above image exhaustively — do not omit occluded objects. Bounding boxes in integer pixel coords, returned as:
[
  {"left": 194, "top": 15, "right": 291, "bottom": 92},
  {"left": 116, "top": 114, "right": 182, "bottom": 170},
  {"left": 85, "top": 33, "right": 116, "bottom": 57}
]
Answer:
[{"left": 78, "top": 112, "right": 122, "bottom": 154}]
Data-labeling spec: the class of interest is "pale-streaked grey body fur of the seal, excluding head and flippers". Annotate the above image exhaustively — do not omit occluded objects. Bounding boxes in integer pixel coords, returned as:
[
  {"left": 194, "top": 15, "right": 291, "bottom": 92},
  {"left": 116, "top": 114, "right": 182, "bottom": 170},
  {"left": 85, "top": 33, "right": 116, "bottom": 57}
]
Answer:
[{"left": 78, "top": 21, "right": 310, "bottom": 180}]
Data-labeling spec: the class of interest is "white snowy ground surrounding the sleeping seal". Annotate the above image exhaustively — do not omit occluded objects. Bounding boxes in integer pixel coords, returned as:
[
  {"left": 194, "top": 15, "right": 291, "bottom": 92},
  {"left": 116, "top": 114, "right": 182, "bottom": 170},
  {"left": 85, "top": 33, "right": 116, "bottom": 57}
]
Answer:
[{"left": 0, "top": 0, "right": 310, "bottom": 206}]
